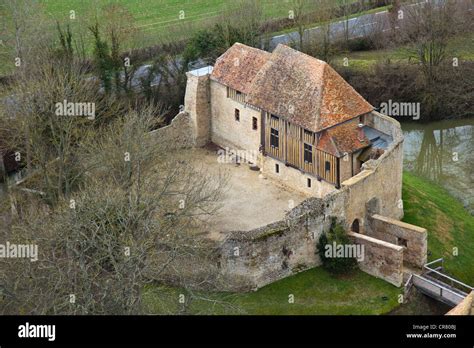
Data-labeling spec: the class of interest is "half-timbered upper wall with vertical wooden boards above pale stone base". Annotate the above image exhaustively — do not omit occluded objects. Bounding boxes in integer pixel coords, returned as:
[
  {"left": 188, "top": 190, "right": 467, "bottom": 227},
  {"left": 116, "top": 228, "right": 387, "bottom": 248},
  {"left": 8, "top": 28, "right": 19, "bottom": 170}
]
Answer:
[{"left": 265, "top": 112, "right": 338, "bottom": 185}]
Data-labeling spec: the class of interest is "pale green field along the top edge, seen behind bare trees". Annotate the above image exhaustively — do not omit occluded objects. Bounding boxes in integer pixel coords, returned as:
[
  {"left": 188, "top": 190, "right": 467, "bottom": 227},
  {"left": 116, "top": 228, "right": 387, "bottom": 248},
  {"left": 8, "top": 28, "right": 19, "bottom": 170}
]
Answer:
[{"left": 0, "top": 0, "right": 357, "bottom": 75}]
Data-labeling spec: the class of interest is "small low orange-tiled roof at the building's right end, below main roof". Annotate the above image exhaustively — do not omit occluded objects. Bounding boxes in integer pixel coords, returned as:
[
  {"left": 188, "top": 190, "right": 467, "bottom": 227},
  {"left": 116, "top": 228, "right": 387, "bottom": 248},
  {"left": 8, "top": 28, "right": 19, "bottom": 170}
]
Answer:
[{"left": 317, "top": 122, "right": 370, "bottom": 157}]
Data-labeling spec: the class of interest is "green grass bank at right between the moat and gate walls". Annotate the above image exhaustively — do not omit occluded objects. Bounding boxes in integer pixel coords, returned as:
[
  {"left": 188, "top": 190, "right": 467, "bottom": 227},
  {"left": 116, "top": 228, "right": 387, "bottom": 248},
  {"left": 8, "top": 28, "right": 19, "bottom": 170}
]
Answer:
[{"left": 403, "top": 172, "right": 474, "bottom": 286}]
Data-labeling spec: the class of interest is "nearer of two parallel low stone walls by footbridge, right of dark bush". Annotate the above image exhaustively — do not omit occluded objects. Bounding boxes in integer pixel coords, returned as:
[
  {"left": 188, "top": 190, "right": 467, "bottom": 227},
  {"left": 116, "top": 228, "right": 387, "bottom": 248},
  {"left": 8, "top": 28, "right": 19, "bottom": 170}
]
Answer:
[{"left": 349, "top": 232, "right": 404, "bottom": 286}]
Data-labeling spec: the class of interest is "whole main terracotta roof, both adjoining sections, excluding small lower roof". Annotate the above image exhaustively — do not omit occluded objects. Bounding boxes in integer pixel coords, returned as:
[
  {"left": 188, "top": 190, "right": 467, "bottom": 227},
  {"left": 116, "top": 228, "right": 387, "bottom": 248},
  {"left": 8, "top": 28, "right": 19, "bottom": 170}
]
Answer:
[{"left": 211, "top": 43, "right": 373, "bottom": 132}]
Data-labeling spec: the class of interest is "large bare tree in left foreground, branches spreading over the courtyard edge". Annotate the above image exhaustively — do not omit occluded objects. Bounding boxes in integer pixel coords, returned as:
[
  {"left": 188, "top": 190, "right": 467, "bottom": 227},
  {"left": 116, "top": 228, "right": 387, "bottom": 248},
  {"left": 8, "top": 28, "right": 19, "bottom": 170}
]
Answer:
[{"left": 0, "top": 109, "right": 230, "bottom": 314}]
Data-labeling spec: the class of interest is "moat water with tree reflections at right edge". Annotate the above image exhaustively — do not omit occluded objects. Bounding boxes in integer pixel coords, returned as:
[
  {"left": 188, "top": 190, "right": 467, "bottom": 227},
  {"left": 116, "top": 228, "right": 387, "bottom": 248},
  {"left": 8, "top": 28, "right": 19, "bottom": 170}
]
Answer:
[{"left": 402, "top": 119, "right": 474, "bottom": 214}]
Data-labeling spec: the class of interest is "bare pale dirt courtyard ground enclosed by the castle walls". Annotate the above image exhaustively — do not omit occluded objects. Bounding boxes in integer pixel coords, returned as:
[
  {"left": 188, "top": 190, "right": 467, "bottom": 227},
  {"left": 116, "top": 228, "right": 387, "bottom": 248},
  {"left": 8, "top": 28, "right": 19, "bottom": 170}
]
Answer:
[{"left": 186, "top": 147, "right": 309, "bottom": 240}]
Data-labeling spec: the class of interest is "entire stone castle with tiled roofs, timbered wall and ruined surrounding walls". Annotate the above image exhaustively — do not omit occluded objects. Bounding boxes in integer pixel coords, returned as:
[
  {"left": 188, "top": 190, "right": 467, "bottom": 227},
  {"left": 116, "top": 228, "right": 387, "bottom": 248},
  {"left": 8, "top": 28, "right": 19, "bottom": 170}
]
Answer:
[{"left": 160, "top": 43, "right": 427, "bottom": 290}]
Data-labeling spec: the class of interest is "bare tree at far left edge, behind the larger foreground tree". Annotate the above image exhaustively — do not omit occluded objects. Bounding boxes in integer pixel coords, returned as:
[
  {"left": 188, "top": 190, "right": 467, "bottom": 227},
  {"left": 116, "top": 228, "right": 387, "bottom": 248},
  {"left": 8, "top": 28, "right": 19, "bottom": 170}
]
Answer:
[{"left": 0, "top": 42, "right": 124, "bottom": 204}]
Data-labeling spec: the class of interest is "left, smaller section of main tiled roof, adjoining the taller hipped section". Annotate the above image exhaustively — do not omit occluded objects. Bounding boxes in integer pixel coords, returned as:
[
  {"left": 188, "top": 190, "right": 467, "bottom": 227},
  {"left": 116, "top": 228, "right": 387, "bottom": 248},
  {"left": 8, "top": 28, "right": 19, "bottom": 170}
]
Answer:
[{"left": 211, "top": 43, "right": 271, "bottom": 94}]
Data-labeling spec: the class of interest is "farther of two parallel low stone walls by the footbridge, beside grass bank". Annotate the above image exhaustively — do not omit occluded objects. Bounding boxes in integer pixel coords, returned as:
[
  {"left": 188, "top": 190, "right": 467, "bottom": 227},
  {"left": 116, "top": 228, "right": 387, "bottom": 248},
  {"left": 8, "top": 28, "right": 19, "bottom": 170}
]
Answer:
[{"left": 368, "top": 215, "right": 428, "bottom": 268}]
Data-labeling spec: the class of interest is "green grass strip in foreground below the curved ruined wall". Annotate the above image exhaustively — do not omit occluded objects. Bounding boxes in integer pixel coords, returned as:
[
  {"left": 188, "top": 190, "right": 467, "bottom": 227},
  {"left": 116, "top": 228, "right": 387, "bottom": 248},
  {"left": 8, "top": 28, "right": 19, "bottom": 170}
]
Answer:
[{"left": 145, "top": 267, "right": 401, "bottom": 315}]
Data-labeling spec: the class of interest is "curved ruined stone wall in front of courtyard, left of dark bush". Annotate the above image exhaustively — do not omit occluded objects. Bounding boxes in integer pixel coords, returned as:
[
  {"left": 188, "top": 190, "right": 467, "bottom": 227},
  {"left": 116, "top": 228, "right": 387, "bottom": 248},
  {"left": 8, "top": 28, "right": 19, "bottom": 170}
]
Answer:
[{"left": 220, "top": 198, "right": 331, "bottom": 291}]
